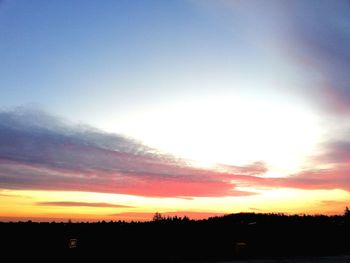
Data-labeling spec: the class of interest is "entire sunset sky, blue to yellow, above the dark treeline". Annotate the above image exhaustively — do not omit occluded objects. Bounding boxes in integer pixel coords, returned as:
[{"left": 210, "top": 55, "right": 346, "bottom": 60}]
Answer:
[{"left": 0, "top": 0, "right": 350, "bottom": 221}]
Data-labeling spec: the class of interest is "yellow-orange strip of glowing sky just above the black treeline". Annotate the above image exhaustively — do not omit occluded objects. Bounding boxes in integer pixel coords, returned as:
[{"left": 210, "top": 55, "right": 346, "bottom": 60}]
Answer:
[{"left": 0, "top": 187, "right": 349, "bottom": 221}]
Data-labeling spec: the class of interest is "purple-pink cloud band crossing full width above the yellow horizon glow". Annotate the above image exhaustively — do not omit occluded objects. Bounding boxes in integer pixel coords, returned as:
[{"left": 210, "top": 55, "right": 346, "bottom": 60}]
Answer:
[{"left": 0, "top": 109, "right": 350, "bottom": 198}]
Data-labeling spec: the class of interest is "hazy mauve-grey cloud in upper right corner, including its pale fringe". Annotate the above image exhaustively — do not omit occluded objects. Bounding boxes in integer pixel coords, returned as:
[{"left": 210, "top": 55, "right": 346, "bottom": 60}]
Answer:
[{"left": 195, "top": 0, "right": 350, "bottom": 115}]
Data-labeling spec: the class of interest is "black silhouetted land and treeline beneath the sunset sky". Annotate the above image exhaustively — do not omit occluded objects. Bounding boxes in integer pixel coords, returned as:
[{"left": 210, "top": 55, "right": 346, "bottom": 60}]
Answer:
[{"left": 0, "top": 213, "right": 350, "bottom": 262}]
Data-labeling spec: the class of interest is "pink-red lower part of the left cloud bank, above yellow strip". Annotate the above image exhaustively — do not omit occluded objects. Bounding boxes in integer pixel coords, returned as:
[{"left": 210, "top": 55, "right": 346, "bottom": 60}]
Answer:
[{"left": 0, "top": 160, "right": 254, "bottom": 197}]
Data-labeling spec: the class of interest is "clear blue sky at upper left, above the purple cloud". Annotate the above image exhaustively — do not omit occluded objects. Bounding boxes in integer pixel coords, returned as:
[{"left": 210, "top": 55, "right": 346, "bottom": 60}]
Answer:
[{"left": 0, "top": 1, "right": 235, "bottom": 120}]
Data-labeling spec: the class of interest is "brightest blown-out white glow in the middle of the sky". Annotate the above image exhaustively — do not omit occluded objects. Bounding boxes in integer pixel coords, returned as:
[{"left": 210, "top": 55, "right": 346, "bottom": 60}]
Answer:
[{"left": 106, "top": 96, "right": 321, "bottom": 176}]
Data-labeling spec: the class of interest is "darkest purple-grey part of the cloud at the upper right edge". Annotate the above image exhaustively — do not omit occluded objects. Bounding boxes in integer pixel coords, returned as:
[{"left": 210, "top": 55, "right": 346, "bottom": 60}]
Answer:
[{"left": 293, "top": 0, "right": 350, "bottom": 114}]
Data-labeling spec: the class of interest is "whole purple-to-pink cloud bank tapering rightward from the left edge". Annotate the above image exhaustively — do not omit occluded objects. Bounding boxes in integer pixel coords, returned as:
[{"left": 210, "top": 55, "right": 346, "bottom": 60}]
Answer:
[{"left": 0, "top": 109, "right": 261, "bottom": 197}]
